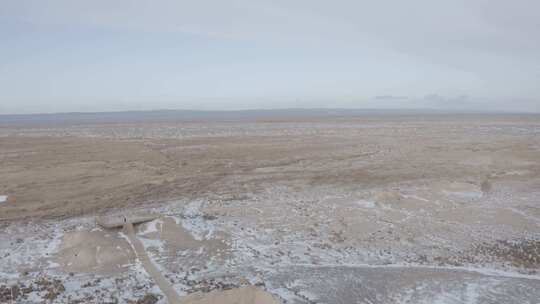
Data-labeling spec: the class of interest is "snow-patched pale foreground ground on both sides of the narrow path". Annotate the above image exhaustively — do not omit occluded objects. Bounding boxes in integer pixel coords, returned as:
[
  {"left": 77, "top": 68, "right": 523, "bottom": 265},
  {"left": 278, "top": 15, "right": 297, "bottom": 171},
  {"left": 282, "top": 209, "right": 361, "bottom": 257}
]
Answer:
[{"left": 0, "top": 182, "right": 540, "bottom": 303}]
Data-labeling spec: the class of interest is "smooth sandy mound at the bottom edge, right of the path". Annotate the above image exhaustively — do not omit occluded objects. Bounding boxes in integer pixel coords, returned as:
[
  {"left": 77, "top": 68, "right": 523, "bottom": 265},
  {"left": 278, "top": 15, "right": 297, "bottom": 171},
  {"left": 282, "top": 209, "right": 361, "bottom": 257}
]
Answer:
[{"left": 182, "top": 286, "right": 280, "bottom": 304}]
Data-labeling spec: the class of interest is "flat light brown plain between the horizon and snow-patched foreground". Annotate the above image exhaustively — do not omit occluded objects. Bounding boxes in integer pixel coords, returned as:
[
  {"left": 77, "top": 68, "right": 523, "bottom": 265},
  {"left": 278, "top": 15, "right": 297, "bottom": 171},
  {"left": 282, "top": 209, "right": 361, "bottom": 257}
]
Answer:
[{"left": 0, "top": 116, "right": 540, "bottom": 219}]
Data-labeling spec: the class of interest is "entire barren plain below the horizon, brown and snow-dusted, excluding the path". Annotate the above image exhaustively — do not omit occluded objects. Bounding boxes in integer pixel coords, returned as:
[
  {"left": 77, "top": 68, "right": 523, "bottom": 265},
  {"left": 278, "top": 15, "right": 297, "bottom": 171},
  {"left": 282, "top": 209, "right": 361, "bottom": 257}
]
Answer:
[{"left": 0, "top": 115, "right": 540, "bottom": 304}]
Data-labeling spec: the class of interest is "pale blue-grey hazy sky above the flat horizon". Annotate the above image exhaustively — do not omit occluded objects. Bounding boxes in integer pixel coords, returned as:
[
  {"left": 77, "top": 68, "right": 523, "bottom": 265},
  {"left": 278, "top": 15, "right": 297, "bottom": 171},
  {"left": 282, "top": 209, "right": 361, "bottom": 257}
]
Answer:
[{"left": 0, "top": 0, "right": 540, "bottom": 114}]
